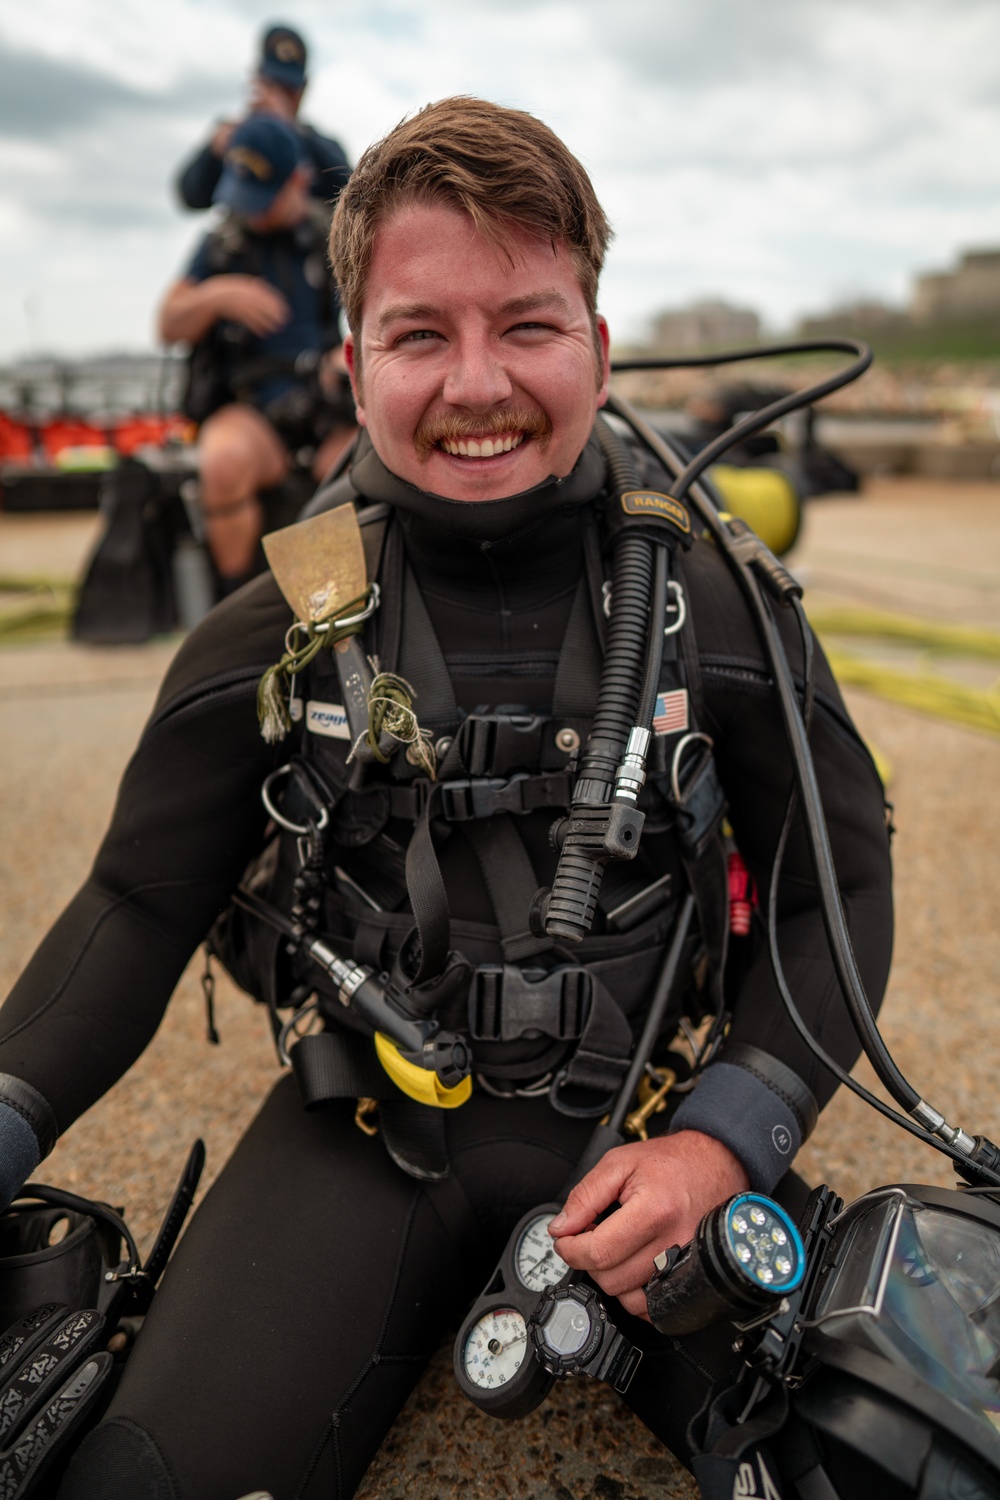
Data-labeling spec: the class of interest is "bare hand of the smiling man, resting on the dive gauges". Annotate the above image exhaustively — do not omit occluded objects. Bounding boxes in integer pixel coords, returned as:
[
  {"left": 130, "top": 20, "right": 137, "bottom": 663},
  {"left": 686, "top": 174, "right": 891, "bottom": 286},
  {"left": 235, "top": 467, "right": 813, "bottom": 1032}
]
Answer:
[{"left": 549, "top": 1130, "right": 750, "bottom": 1319}]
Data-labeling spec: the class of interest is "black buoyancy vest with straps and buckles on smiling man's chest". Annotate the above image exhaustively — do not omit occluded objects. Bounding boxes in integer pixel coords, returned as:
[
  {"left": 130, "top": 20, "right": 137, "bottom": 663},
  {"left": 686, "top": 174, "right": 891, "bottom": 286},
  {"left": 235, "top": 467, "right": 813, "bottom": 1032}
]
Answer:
[{"left": 212, "top": 438, "right": 724, "bottom": 1095}]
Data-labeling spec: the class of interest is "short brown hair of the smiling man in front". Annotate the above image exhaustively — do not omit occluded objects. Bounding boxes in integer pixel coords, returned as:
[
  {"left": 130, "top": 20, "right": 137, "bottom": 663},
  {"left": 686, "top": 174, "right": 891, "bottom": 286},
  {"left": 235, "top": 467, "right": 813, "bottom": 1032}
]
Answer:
[{"left": 330, "top": 95, "right": 612, "bottom": 333}]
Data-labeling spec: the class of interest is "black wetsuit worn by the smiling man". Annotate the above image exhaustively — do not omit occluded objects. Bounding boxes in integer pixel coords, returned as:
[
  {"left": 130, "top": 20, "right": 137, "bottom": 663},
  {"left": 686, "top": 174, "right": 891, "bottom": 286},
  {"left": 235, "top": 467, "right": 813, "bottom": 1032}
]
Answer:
[{"left": 0, "top": 432, "right": 892, "bottom": 1500}]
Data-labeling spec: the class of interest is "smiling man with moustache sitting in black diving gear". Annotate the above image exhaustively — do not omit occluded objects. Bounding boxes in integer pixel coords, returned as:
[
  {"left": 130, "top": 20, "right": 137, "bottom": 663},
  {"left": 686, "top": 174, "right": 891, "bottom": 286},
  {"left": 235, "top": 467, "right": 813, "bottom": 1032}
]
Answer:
[{"left": 0, "top": 99, "right": 891, "bottom": 1500}]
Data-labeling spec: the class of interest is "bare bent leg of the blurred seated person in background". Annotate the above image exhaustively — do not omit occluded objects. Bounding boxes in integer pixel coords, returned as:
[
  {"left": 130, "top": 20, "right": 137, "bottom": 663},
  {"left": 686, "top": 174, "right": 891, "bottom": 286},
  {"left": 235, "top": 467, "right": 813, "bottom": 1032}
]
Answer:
[{"left": 199, "top": 405, "right": 288, "bottom": 581}]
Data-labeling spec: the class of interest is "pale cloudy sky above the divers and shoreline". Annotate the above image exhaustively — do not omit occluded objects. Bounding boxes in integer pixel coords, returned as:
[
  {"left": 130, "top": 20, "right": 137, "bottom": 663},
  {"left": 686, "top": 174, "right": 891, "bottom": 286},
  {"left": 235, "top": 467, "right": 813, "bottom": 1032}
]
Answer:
[{"left": 0, "top": 0, "right": 1000, "bottom": 359}]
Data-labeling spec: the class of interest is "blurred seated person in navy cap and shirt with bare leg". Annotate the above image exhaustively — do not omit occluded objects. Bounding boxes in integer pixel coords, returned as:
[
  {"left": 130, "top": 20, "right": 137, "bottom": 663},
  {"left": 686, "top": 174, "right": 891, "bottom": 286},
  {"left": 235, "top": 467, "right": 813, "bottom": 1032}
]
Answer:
[{"left": 159, "top": 114, "right": 355, "bottom": 596}]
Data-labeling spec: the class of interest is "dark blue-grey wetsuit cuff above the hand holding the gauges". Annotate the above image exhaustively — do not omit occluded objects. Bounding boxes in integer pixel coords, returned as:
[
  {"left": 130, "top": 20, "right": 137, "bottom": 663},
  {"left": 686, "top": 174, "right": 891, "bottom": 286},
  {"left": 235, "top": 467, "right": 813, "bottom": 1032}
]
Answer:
[{"left": 670, "top": 1047, "right": 817, "bottom": 1193}]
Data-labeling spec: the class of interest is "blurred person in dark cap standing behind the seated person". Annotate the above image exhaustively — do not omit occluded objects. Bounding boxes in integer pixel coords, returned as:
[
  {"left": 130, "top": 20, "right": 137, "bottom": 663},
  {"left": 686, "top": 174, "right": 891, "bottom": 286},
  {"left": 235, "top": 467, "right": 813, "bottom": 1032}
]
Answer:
[{"left": 177, "top": 26, "right": 351, "bottom": 209}]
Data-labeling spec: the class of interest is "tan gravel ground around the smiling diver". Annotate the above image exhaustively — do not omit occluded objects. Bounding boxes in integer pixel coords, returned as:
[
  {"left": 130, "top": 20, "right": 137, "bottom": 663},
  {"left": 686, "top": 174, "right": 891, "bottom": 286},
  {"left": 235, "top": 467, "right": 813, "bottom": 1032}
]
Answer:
[{"left": 0, "top": 480, "right": 1000, "bottom": 1500}]
